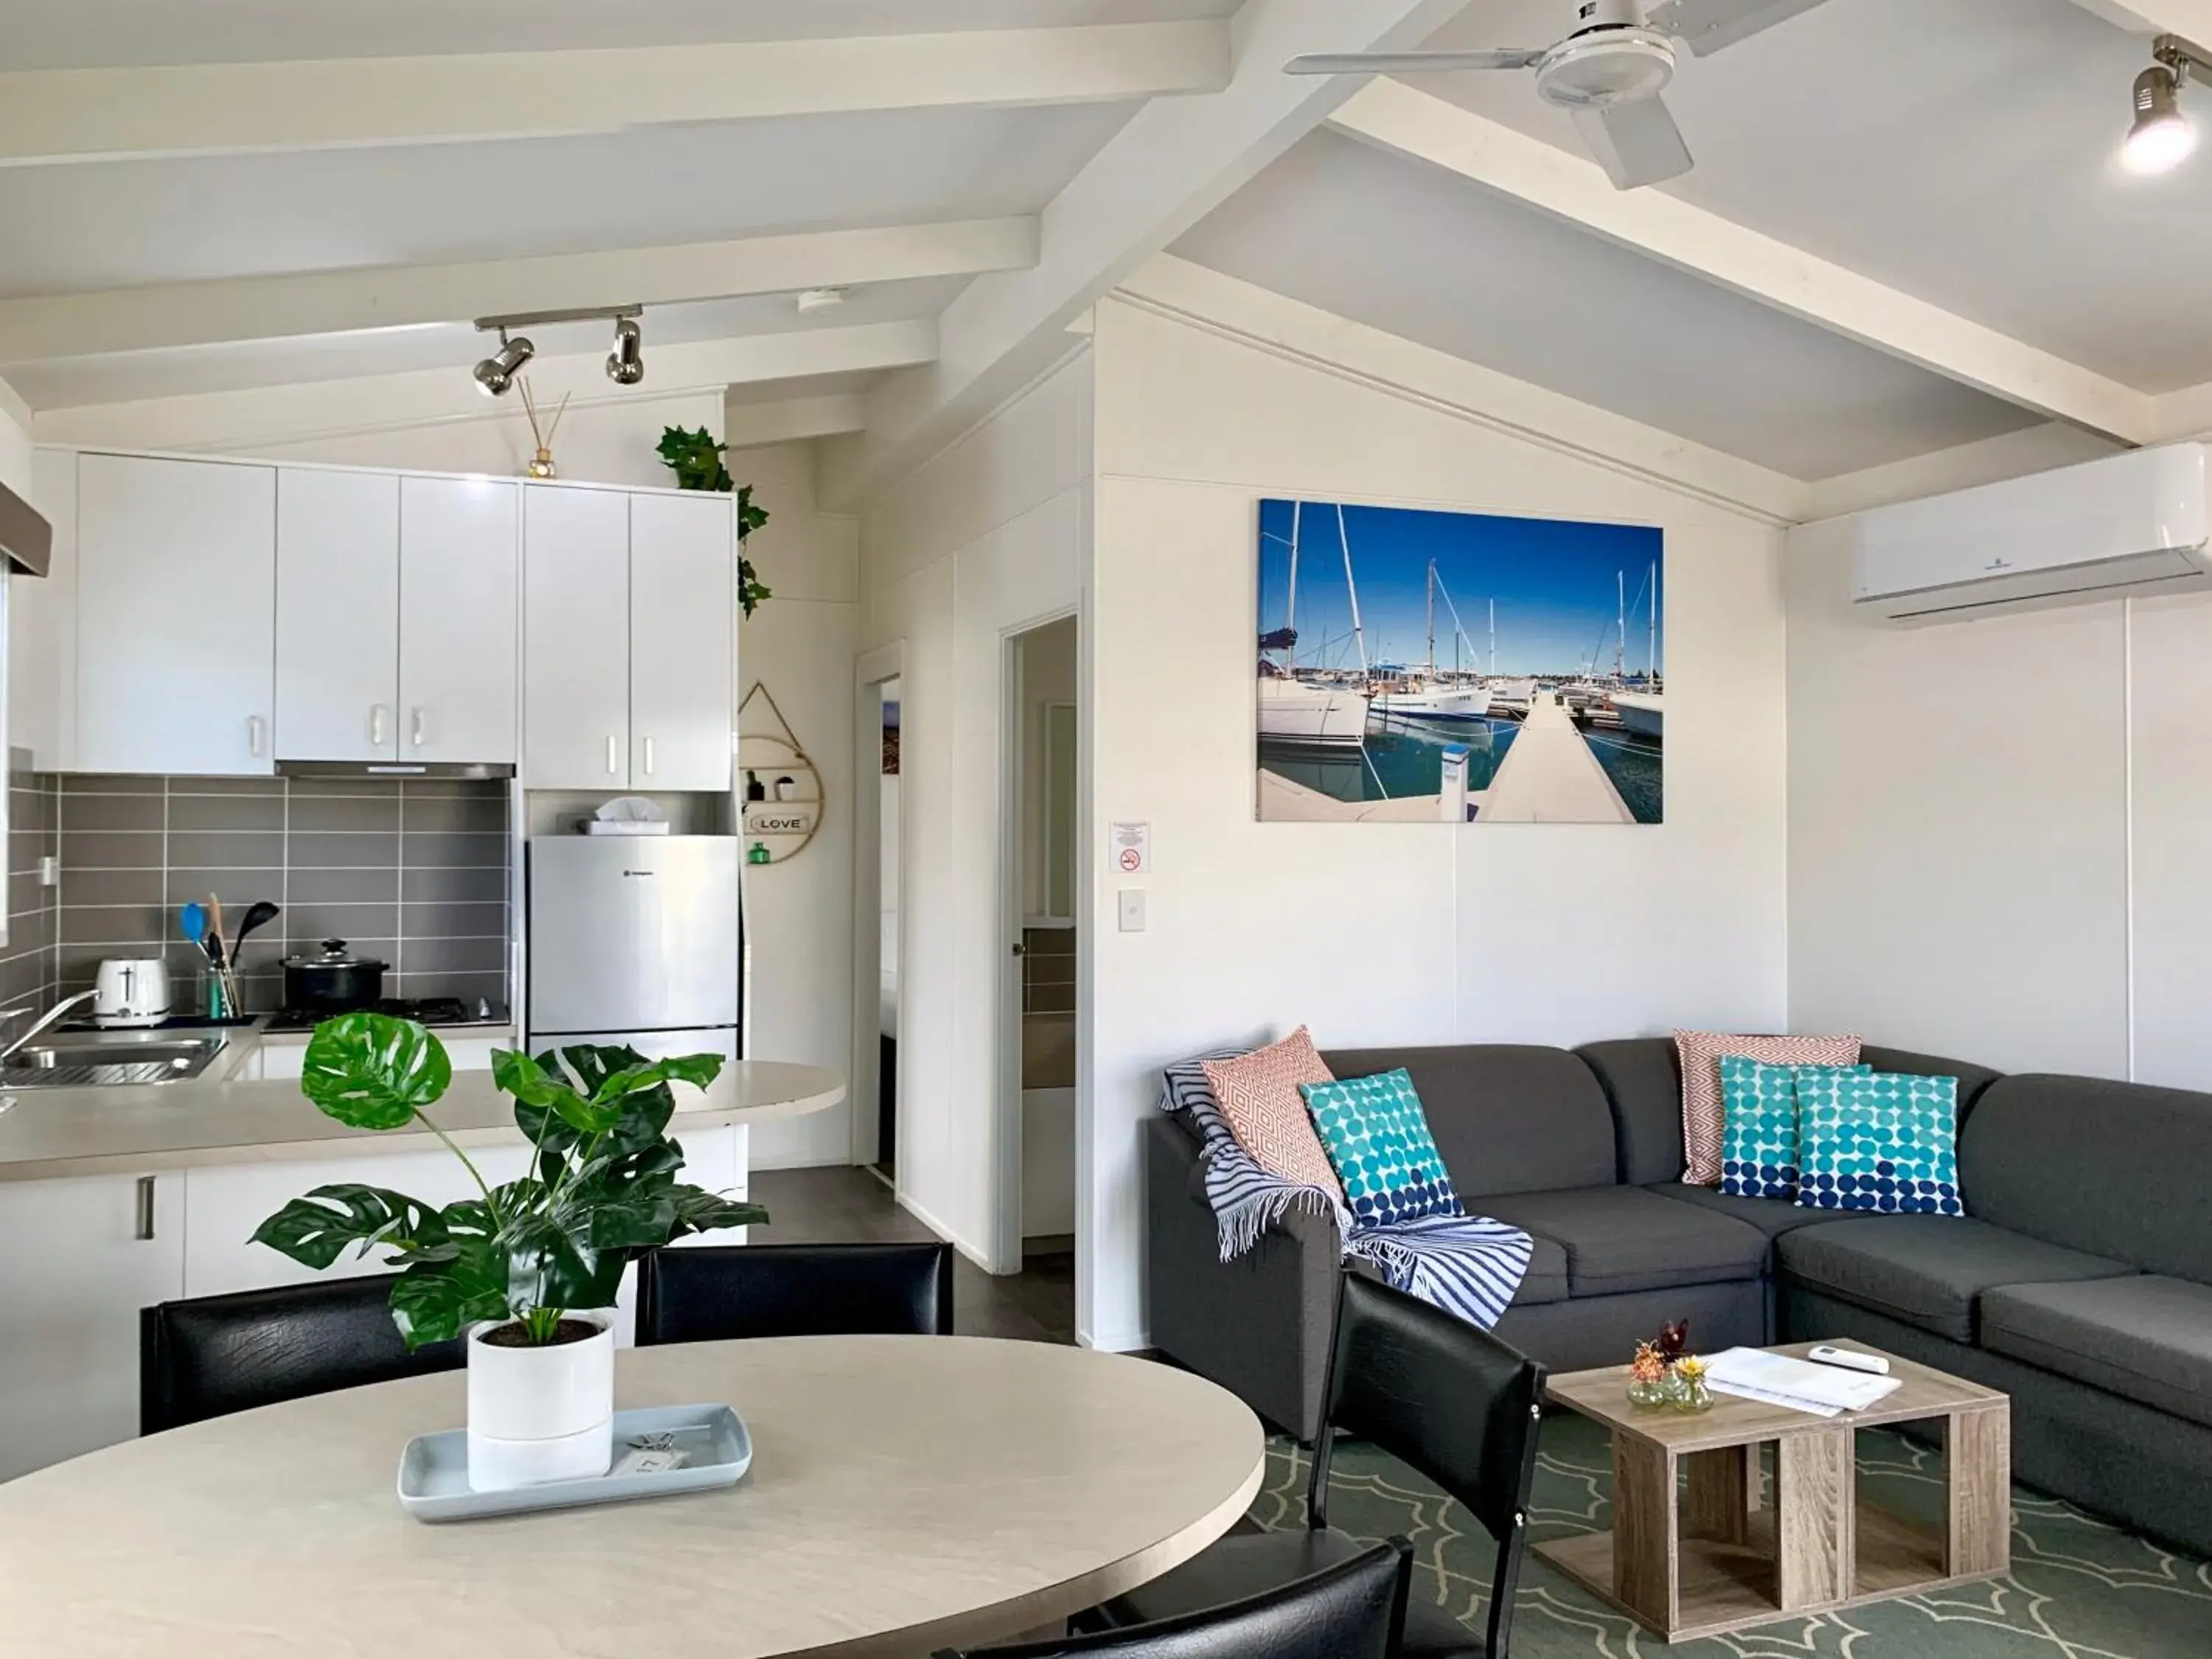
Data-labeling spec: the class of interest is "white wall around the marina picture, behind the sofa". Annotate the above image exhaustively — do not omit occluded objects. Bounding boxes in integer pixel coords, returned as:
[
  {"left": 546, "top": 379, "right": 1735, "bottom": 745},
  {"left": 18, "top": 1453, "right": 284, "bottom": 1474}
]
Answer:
[{"left": 1077, "top": 290, "right": 1787, "bottom": 1347}]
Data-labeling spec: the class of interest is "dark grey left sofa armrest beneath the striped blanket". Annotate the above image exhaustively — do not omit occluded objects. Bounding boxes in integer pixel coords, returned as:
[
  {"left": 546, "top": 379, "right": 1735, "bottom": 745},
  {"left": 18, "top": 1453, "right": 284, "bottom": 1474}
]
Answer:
[{"left": 1144, "top": 1117, "right": 1340, "bottom": 1440}]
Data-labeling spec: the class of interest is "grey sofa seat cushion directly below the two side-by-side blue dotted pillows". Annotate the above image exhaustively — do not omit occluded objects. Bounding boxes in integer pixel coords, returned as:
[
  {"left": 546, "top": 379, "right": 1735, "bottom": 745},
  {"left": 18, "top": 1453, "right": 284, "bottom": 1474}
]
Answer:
[{"left": 1774, "top": 1214, "right": 2135, "bottom": 1343}]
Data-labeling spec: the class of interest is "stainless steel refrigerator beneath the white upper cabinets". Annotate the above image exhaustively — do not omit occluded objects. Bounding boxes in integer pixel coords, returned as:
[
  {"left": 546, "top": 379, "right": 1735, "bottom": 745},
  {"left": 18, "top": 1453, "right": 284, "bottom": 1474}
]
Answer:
[{"left": 524, "top": 834, "right": 743, "bottom": 1060}]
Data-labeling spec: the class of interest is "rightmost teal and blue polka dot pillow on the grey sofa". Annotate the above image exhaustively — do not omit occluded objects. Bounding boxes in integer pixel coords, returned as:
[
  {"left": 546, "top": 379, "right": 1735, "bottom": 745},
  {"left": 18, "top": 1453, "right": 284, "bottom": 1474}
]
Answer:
[{"left": 1796, "top": 1071, "right": 1964, "bottom": 1214}]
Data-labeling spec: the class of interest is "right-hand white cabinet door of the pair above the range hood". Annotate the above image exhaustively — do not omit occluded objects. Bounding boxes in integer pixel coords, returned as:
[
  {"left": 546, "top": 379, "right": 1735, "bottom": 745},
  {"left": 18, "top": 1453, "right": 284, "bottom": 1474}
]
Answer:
[{"left": 398, "top": 478, "right": 522, "bottom": 765}]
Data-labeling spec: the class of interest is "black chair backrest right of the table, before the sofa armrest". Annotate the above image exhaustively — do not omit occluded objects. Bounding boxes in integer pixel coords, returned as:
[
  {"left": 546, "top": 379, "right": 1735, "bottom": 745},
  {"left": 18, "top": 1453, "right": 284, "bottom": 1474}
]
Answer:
[{"left": 1307, "top": 1272, "right": 1544, "bottom": 1659}]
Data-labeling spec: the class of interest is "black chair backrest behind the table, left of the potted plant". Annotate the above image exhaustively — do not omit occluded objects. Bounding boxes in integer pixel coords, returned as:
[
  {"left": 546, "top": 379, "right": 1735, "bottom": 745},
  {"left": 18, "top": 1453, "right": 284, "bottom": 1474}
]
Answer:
[{"left": 139, "top": 1274, "right": 467, "bottom": 1433}]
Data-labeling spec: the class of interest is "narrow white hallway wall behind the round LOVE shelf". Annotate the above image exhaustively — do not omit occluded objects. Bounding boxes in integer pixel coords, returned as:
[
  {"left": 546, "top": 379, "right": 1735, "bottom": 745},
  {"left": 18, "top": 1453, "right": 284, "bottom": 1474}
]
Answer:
[{"left": 730, "top": 442, "right": 860, "bottom": 1170}]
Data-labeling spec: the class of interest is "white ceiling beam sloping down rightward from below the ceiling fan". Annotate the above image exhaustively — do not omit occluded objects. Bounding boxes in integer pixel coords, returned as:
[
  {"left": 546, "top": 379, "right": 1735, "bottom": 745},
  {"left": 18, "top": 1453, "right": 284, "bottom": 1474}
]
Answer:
[{"left": 1329, "top": 80, "right": 2154, "bottom": 442}]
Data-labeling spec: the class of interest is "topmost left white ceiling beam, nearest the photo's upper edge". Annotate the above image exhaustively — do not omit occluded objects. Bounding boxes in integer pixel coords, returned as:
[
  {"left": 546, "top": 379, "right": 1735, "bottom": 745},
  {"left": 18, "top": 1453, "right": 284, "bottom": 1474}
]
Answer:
[{"left": 0, "top": 20, "right": 1230, "bottom": 166}]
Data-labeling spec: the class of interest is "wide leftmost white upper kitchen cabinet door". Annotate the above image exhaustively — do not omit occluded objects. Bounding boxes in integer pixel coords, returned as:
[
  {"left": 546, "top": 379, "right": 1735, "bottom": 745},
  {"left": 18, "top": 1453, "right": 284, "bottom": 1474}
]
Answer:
[{"left": 73, "top": 456, "right": 276, "bottom": 776}]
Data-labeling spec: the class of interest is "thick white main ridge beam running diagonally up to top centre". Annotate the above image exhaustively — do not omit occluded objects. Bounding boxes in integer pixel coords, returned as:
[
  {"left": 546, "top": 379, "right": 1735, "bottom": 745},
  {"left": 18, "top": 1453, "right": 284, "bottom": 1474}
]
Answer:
[{"left": 823, "top": 0, "right": 1467, "bottom": 507}]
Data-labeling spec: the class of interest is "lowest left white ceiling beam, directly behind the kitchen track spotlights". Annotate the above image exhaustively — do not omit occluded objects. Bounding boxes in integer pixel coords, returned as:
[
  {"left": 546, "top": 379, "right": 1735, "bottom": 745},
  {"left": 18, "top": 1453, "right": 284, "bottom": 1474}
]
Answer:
[{"left": 31, "top": 319, "right": 938, "bottom": 453}]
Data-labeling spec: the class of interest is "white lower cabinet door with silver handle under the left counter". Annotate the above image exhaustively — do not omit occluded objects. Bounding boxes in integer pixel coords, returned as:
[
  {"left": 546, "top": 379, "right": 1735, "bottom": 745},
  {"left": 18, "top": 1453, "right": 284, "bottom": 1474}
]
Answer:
[{"left": 0, "top": 1175, "right": 184, "bottom": 1480}]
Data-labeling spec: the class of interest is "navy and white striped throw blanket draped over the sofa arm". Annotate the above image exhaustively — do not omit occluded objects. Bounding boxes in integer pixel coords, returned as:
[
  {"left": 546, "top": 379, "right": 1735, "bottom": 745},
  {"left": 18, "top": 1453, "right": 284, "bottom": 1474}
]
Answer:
[{"left": 1159, "top": 1048, "right": 1535, "bottom": 1329}]
